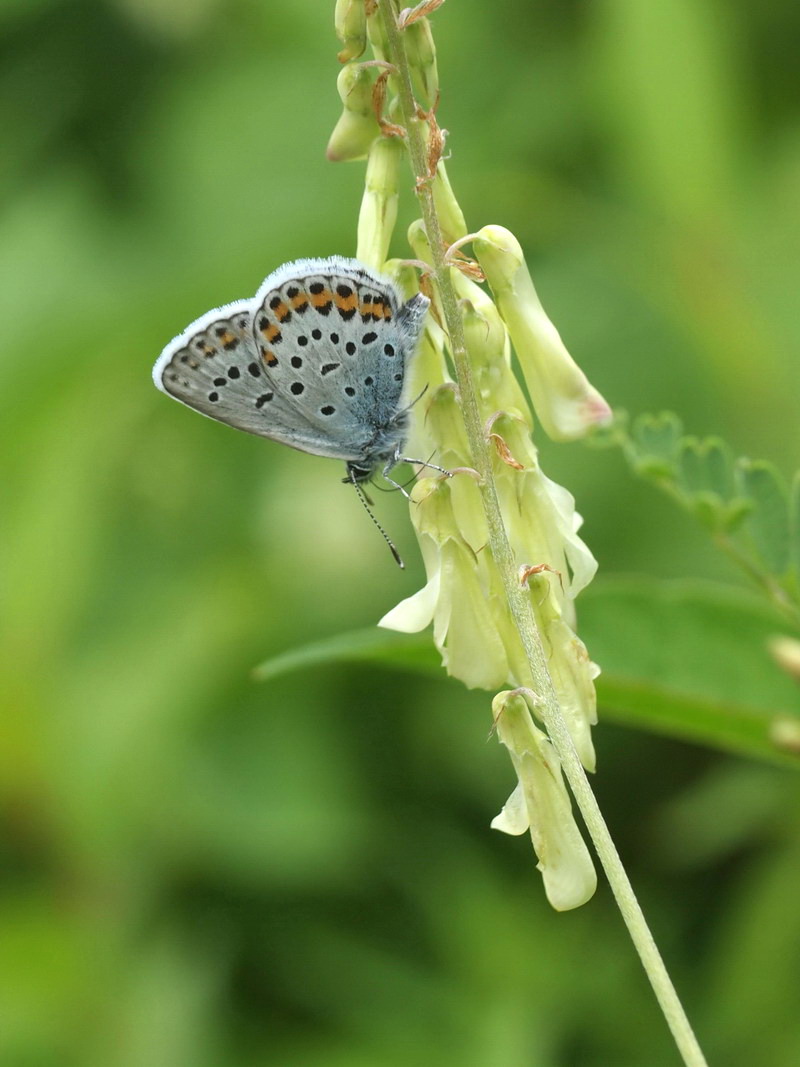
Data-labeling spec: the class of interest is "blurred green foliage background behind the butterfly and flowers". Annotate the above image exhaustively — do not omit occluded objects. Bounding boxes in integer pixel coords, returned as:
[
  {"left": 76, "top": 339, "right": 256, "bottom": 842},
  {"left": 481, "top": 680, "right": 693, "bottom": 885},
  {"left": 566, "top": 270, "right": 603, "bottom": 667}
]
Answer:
[{"left": 0, "top": 0, "right": 800, "bottom": 1067}]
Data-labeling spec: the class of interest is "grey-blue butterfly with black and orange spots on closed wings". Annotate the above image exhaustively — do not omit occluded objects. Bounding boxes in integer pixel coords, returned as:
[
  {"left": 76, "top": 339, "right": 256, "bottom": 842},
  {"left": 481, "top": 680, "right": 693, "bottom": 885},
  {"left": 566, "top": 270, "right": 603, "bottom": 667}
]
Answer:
[{"left": 153, "top": 256, "right": 429, "bottom": 482}]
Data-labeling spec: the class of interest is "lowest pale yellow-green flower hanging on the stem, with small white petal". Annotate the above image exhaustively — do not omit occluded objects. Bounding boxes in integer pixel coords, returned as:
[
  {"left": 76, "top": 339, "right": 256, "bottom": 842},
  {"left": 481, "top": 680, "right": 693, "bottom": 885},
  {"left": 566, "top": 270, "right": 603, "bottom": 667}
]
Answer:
[{"left": 492, "top": 690, "right": 597, "bottom": 911}]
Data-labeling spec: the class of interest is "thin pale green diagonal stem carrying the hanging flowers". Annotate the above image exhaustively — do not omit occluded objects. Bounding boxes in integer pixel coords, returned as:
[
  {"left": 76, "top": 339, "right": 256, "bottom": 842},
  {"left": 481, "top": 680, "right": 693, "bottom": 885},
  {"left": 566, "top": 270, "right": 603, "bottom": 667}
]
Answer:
[{"left": 378, "top": 0, "right": 706, "bottom": 1067}]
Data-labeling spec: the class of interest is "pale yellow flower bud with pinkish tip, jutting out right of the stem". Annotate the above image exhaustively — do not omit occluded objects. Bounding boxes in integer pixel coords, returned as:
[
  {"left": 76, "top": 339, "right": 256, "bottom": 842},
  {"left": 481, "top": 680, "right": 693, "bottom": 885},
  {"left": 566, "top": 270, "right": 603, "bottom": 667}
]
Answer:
[{"left": 473, "top": 226, "right": 611, "bottom": 441}]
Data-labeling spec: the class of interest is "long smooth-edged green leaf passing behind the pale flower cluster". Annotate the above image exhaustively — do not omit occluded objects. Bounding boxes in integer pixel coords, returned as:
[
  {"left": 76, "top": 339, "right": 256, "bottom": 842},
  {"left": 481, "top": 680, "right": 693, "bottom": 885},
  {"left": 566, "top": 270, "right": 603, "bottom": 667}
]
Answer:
[{"left": 255, "top": 577, "right": 800, "bottom": 769}]
